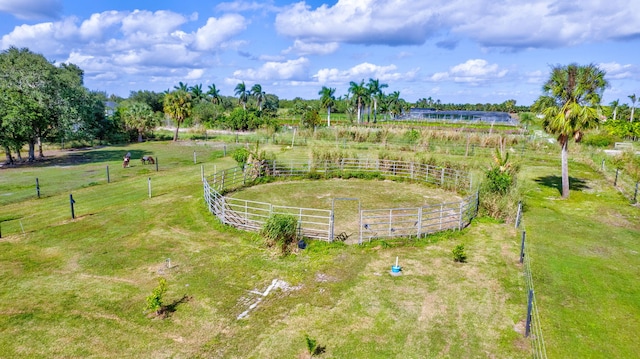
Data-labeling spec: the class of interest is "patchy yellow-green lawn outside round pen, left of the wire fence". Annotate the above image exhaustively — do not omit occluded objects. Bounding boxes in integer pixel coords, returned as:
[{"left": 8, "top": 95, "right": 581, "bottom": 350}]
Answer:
[{"left": 0, "top": 143, "right": 528, "bottom": 358}]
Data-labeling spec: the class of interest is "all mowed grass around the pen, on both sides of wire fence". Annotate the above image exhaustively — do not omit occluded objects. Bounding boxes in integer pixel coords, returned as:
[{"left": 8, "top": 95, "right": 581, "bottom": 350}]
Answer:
[{"left": 0, "top": 136, "right": 640, "bottom": 358}]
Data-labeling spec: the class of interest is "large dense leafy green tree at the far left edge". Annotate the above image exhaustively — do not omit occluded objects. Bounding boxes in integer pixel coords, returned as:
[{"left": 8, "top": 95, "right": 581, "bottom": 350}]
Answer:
[{"left": 0, "top": 47, "right": 99, "bottom": 161}]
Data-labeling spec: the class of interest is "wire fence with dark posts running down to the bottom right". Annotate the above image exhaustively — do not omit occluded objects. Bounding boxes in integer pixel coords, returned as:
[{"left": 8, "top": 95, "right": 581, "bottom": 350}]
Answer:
[{"left": 515, "top": 202, "right": 547, "bottom": 359}]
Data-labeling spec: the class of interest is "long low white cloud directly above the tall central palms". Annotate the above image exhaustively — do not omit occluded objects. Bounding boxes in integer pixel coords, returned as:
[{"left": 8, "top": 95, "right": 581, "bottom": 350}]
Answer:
[{"left": 313, "top": 62, "right": 419, "bottom": 84}]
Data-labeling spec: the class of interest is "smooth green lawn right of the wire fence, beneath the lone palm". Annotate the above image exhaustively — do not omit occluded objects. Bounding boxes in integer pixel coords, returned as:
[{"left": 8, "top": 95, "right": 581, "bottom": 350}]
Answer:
[{"left": 523, "top": 153, "right": 640, "bottom": 358}]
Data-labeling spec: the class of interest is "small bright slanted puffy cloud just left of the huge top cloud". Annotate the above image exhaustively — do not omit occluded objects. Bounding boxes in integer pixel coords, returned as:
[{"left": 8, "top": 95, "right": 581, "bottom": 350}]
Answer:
[{"left": 194, "top": 14, "right": 247, "bottom": 51}]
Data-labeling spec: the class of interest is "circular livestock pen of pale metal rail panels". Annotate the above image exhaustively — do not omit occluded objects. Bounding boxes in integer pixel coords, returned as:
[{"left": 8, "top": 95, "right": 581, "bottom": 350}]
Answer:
[{"left": 203, "top": 159, "right": 478, "bottom": 243}]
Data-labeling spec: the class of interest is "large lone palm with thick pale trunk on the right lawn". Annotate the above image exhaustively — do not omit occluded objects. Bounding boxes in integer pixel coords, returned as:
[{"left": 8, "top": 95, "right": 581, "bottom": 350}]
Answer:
[{"left": 532, "top": 64, "right": 608, "bottom": 198}]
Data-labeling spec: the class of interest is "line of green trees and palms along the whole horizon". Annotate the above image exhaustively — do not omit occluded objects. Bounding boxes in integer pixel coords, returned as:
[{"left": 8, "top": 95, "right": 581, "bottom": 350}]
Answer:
[{"left": 0, "top": 47, "right": 640, "bottom": 169}]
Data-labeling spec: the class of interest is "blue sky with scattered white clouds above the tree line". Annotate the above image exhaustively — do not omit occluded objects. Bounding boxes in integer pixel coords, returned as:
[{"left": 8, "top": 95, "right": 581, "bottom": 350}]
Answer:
[{"left": 0, "top": 0, "right": 640, "bottom": 105}]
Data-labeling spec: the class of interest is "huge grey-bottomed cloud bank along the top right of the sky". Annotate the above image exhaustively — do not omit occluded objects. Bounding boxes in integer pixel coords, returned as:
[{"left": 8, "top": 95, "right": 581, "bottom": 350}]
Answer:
[{"left": 276, "top": 0, "right": 640, "bottom": 49}]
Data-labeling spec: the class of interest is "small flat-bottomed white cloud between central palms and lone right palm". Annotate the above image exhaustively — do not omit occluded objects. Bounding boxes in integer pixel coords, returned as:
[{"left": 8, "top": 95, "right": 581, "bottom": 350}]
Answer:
[{"left": 431, "top": 59, "right": 508, "bottom": 84}]
